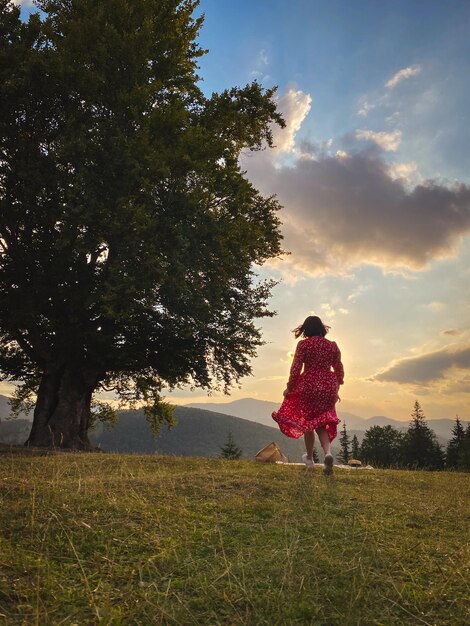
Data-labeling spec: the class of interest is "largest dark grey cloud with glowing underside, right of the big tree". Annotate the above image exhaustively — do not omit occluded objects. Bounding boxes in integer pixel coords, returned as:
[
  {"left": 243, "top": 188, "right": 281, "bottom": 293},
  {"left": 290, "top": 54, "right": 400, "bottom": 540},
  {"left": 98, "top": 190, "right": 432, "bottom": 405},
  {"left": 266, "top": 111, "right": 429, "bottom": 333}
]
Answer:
[{"left": 243, "top": 147, "right": 470, "bottom": 275}]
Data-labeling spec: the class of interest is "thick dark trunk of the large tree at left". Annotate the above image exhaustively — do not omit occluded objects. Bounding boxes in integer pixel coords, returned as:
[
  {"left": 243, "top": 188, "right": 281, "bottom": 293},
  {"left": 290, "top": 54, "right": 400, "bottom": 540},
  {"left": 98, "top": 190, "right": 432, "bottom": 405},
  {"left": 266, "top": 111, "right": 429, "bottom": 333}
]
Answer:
[{"left": 25, "top": 365, "right": 101, "bottom": 450}]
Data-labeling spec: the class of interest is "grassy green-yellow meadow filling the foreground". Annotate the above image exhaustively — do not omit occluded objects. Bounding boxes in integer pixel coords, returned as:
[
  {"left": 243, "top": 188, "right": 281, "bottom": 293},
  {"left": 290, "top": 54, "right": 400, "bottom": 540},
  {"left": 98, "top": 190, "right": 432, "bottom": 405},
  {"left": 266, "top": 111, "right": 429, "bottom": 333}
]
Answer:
[{"left": 0, "top": 453, "right": 470, "bottom": 626}]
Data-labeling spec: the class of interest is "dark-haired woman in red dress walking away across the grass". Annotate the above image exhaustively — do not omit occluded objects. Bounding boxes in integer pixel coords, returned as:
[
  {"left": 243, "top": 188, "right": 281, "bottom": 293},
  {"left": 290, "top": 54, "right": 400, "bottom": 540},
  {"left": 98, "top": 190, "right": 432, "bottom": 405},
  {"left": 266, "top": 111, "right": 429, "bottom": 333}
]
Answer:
[{"left": 272, "top": 315, "right": 344, "bottom": 475}]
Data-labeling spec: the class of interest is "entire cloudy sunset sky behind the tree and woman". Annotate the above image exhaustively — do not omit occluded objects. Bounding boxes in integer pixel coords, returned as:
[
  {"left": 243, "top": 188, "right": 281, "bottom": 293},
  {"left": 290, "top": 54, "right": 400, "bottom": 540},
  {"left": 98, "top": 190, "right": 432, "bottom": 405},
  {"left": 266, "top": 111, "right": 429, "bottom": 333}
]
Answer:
[{"left": 10, "top": 0, "right": 470, "bottom": 420}]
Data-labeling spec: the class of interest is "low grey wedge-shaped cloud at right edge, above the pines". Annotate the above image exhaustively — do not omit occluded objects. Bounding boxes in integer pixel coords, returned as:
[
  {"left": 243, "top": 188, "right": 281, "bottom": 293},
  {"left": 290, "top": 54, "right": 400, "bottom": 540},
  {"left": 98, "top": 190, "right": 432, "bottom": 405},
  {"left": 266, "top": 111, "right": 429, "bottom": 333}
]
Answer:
[{"left": 372, "top": 344, "right": 470, "bottom": 385}]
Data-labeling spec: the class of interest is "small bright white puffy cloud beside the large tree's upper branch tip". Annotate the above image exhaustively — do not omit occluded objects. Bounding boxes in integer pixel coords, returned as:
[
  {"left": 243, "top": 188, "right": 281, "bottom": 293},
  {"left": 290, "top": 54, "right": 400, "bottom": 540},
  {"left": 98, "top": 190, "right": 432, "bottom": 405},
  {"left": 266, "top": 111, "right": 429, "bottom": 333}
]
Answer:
[{"left": 273, "top": 89, "right": 312, "bottom": 156}]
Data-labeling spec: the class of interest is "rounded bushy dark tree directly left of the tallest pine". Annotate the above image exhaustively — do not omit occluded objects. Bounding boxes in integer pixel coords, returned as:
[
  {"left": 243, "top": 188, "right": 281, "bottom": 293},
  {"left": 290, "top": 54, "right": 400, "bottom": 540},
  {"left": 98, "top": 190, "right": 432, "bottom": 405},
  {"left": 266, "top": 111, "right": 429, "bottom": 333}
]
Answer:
[{"left": 360, "top": 425, "right": 403, "bottom": 467}]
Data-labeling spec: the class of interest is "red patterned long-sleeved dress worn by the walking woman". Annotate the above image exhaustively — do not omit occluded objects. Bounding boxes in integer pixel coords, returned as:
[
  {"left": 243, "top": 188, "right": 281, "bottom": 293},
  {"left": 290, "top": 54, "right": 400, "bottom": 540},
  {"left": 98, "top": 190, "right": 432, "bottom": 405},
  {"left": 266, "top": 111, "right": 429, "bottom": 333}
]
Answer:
[{"left": 272, "top": 337, "right": 344, "bottom": 441}]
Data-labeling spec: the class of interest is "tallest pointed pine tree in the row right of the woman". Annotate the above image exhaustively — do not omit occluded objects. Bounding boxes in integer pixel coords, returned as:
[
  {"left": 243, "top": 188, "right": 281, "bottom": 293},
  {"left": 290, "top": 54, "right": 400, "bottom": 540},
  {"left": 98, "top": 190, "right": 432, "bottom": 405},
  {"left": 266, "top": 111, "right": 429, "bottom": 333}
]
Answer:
[{"left": 403, "top": 400, "right": 444, "bottom": 469}]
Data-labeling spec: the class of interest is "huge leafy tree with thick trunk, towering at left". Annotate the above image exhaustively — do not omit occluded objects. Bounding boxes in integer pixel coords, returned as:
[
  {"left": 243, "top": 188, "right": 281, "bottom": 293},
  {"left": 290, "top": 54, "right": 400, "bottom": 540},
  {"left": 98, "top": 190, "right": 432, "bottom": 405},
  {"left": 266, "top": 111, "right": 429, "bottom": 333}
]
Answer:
[{"left": 0, "top": 0, "right": 283, "bottom": 449}]
